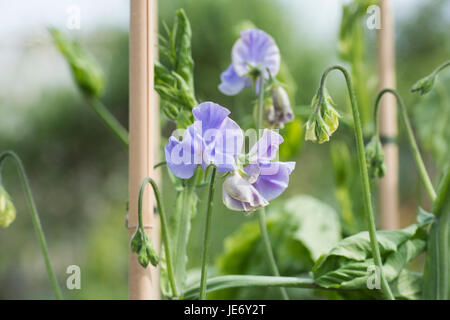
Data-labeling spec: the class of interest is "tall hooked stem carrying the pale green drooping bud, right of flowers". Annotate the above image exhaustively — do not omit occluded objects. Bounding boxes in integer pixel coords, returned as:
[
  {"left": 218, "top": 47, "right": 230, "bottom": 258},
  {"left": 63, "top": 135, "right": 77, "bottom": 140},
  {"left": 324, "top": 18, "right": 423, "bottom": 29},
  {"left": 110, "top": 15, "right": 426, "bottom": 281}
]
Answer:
[{"left": 318, "top": 65, "right": 394, "bottom": 300}]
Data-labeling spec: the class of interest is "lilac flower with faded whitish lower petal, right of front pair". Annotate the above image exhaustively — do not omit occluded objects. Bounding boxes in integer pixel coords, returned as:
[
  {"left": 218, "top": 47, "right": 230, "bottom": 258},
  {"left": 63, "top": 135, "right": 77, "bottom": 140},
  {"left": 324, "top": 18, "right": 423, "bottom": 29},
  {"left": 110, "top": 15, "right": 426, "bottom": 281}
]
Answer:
[{"left": 222, "top": 129, "right": 295, "bottom": 213}]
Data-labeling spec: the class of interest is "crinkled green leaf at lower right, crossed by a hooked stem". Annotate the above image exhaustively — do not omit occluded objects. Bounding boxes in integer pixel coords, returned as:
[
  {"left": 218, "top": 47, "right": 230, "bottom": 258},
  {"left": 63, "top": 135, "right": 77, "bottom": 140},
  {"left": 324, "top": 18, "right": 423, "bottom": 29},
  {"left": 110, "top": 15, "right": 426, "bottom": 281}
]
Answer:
[{"left": 313, "top": 212, "right": 429, "bottom": 289}]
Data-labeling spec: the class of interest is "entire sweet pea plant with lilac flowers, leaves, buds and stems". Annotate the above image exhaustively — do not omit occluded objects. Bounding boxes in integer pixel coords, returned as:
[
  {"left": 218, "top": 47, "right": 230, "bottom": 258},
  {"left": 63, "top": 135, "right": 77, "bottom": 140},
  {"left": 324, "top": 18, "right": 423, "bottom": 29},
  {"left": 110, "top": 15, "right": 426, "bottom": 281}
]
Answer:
[{"left": 0, "top": 10, "right": 450, "bottom": 300}]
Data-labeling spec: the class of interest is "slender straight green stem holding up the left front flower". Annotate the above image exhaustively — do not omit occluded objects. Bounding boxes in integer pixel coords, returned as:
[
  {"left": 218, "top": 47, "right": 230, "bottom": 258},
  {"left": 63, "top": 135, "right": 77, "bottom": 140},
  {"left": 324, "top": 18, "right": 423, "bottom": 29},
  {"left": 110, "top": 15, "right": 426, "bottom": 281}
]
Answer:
[{"left": 200, "top": 166, "right": 216, "bottom": 300}]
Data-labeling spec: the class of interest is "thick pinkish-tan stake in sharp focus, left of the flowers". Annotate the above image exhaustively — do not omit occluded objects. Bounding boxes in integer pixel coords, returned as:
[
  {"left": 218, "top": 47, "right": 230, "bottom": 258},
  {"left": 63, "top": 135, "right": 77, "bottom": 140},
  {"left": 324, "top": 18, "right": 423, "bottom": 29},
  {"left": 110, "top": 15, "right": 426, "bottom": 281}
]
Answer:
[{"left": 128, "top": 0, "right": 160, "bottom": 300}]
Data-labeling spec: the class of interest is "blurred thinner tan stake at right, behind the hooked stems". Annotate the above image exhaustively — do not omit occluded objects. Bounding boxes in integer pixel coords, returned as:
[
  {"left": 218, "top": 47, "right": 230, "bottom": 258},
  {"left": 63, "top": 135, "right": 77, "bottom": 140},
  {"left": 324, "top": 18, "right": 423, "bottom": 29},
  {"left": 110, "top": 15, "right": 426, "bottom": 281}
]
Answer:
[{"left": 378, "top": 0, "right": 400, "bottom": 229}]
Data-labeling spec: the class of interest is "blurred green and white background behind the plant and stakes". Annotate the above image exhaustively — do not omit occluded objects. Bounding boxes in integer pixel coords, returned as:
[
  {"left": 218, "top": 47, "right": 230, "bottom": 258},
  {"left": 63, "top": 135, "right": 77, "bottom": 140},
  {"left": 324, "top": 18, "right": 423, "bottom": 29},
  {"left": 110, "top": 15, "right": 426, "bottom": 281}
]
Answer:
[{"left": 0, "top": 0, "right": 450, "bottom": 299}]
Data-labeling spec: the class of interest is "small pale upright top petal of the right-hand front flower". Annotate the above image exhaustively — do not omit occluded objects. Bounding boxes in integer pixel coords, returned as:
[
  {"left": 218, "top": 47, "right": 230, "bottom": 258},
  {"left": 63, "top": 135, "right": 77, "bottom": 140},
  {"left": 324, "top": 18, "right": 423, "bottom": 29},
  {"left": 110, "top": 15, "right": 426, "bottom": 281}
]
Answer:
[{"left": 249, "top": 129, "right": 283, "bottom": 163}]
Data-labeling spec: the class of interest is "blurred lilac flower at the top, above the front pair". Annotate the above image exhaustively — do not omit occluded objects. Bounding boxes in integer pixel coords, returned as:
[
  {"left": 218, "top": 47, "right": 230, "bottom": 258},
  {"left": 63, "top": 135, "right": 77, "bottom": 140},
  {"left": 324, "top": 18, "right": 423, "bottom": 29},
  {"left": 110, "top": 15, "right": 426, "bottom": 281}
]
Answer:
[{"left": 219, "top": 29, "right": 280, "bottom": 96}]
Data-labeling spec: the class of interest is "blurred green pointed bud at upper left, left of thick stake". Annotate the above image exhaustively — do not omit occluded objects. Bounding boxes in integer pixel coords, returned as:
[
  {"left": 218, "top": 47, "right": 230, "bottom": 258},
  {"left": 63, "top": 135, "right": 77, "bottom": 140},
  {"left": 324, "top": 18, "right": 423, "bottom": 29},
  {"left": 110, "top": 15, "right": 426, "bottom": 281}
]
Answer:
[{"left": 49, "top": 28, "right": 105, "bottom": 97}]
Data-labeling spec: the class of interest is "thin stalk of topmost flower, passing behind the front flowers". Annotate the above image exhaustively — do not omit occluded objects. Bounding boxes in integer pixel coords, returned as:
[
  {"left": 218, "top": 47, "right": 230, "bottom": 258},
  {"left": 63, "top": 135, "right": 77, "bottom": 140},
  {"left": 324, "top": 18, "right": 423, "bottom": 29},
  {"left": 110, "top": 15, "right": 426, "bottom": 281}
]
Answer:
[{"left": 256, "top": 77, "right": 289, "bottom": 300}]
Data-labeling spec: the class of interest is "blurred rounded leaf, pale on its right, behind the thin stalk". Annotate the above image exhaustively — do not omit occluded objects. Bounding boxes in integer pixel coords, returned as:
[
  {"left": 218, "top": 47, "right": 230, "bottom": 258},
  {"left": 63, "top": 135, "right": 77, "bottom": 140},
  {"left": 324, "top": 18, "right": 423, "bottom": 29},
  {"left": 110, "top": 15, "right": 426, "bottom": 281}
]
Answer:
[{"left": 214, "top": 195, "right": 340, "bottom": 299}]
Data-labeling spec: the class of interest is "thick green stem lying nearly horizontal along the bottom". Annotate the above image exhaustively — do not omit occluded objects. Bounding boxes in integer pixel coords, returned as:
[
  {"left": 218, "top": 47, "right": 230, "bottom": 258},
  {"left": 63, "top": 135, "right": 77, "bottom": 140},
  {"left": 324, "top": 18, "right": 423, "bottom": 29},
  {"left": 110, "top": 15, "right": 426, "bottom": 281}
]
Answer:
[{"left": 183, "top": 275, "right": 316, "bottom": 299}]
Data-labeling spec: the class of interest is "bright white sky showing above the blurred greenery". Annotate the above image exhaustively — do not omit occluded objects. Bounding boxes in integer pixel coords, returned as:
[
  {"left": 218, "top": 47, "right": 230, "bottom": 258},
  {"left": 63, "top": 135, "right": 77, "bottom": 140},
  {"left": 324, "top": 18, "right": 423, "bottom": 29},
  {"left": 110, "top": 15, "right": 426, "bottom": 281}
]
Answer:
[{"left": 0, "top": 0, "right": 442, "bottom": 109}]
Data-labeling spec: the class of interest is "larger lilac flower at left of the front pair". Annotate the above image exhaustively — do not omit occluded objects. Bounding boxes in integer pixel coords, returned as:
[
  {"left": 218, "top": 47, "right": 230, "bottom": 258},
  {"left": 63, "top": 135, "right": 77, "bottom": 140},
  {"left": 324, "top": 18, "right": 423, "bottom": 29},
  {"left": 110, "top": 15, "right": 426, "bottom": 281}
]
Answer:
[{"left": 164, "top": 102, "right": 243, "bottom": 179}]
